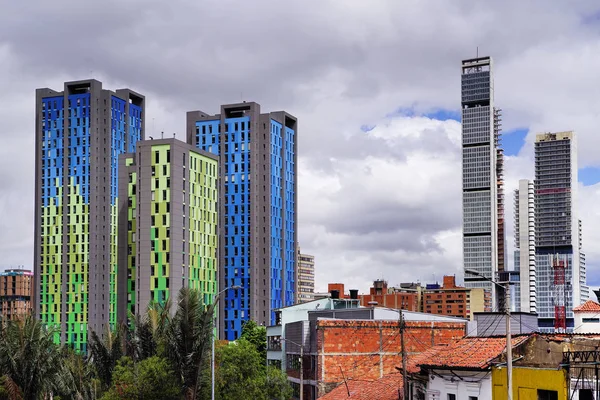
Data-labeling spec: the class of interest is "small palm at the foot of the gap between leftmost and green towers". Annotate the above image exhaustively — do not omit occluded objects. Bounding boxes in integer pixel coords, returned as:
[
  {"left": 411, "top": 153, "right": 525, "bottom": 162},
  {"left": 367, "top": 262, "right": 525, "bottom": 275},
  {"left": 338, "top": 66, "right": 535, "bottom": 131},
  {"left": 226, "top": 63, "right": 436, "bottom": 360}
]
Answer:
[{"left": 88, "top": 325, "right": 125, "bottom": 389}]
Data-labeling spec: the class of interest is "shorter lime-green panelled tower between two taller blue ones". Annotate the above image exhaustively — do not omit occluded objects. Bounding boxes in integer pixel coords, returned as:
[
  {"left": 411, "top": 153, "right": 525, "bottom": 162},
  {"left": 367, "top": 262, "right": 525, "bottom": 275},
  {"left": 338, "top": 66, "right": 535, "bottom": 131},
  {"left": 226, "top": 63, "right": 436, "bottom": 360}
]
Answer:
[{"left": 117, "top": 139, "right": 218, "bottom": 321}]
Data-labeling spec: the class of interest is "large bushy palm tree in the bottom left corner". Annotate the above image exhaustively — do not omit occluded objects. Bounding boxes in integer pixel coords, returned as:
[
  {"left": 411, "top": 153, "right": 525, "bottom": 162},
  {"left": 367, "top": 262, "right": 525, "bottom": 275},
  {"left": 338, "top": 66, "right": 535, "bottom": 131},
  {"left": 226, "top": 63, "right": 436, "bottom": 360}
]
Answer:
[{"left": 0, "top": 316, "right": 61, "bottom": 400}]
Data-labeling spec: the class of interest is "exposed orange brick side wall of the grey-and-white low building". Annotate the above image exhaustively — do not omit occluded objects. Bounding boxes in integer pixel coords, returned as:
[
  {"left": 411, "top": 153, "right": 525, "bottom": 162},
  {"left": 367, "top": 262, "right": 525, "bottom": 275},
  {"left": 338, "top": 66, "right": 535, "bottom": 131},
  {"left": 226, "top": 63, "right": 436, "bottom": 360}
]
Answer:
[{"left": 314, "top": 320, "right": 466, "bottom": 396}]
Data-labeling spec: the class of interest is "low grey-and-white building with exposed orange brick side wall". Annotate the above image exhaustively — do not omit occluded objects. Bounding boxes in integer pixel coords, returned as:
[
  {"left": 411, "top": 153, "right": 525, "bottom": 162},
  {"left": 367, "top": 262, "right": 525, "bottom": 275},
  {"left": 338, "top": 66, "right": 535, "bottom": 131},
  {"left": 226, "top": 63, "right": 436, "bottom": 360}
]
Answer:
[{"left": 267, "top": 290, "right": 469, "bottom": 400}]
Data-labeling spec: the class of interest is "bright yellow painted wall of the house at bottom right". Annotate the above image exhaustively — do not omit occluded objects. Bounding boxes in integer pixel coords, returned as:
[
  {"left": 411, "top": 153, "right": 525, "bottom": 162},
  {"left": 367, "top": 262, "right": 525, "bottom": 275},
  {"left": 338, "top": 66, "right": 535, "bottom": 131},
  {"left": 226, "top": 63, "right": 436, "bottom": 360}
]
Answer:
[{"left": 492, "top": 367, "right": 568, "bottom": 400}]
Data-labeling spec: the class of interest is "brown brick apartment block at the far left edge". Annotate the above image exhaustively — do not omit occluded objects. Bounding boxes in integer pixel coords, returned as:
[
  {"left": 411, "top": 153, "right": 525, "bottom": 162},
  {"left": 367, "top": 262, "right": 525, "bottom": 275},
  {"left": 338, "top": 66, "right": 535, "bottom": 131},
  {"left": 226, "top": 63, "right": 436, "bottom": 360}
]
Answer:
[{"left": 0, "top": 269, "right": 34, "bottom": 320}]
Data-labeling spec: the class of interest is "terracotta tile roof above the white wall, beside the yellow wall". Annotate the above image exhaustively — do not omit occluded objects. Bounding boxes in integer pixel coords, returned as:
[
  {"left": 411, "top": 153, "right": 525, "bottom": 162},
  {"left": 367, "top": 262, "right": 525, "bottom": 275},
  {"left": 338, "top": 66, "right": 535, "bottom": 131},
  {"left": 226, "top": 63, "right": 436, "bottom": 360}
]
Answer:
[{"left": 409, "top": 335, "right": 529, "bottom": 372}]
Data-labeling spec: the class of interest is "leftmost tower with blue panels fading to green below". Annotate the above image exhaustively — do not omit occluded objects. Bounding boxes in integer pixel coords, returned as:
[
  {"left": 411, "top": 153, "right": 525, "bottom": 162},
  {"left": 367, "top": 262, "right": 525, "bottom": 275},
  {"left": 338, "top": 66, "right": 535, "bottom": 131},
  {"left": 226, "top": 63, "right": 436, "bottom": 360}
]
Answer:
[{"left": 34, "top": 80, "right": 144, "bottom": 351}]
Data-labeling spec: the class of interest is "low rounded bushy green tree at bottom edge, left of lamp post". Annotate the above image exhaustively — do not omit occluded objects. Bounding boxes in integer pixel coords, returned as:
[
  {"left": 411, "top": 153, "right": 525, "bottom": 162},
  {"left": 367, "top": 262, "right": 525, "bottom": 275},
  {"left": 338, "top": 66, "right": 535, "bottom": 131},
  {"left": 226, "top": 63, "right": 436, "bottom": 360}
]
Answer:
[{"left": 101, "top": 356, "right": 181, "bottom": 400}]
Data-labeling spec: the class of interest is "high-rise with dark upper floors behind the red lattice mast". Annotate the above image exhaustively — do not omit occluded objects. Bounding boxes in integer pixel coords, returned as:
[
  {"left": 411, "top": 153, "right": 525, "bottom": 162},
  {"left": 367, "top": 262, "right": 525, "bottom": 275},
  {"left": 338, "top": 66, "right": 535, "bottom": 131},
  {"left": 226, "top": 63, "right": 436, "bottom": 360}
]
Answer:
[{"left": 535, "top": 132, "right": 589, "bottom": 331}]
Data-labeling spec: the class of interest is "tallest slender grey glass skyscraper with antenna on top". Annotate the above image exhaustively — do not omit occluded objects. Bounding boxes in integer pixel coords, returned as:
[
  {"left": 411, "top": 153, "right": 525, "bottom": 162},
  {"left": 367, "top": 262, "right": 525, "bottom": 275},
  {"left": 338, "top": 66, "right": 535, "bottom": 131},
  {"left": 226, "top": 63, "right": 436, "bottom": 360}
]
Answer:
[{"left": 461, "top": 57, "right": 506, "bottom": 311}]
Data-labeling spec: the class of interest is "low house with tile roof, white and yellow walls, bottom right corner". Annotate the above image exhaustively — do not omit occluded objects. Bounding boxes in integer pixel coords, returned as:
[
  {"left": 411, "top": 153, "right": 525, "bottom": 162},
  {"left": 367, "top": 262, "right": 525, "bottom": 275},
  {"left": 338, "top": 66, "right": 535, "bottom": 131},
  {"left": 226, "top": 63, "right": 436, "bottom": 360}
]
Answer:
[{"left": 408, "top": 333, "right": 600, "bottom": 400}]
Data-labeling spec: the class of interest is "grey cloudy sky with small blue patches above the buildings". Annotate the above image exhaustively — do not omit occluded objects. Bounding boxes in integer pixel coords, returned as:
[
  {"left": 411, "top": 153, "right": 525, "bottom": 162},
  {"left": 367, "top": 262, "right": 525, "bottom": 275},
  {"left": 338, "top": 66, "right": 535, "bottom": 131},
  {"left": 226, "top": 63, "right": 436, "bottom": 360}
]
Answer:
[{"left": 0, "top": 0, "right": 600, "bottom": 292}]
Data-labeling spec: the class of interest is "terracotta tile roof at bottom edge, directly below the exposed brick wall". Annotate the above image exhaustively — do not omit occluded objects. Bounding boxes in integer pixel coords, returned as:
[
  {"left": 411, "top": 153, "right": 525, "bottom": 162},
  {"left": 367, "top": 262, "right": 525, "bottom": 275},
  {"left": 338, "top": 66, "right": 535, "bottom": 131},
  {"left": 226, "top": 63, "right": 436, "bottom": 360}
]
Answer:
[{"left": 319, "top": 373, "right": 402, "bottom": 400}]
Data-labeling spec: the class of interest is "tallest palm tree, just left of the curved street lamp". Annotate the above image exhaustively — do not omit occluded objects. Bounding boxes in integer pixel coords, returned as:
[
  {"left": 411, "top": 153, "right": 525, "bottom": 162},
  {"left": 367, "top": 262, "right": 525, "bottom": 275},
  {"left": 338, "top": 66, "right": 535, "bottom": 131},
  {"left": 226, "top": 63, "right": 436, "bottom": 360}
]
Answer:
[{"left": 165, "top": 288, "right": 212, "bottom": 400}]
